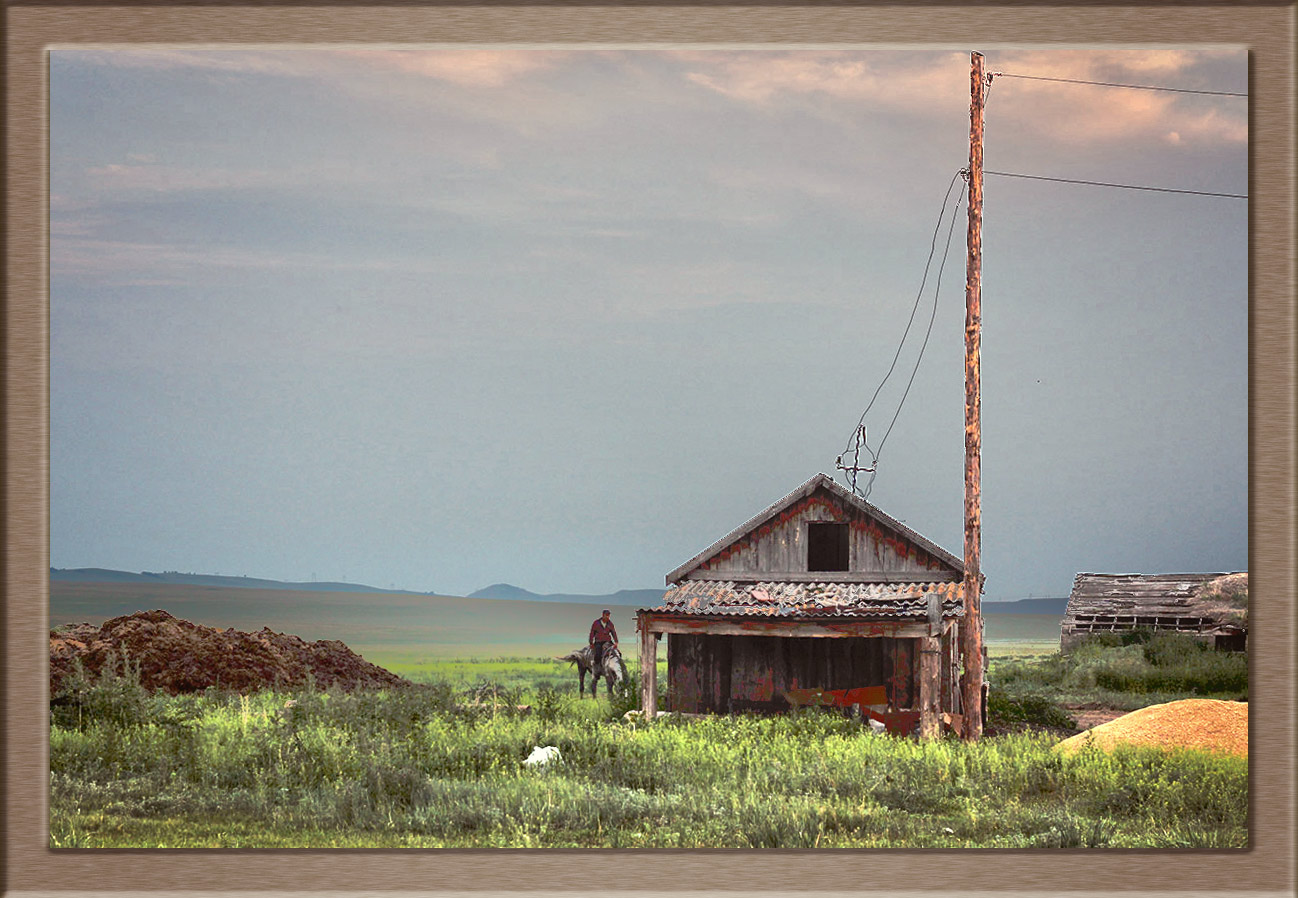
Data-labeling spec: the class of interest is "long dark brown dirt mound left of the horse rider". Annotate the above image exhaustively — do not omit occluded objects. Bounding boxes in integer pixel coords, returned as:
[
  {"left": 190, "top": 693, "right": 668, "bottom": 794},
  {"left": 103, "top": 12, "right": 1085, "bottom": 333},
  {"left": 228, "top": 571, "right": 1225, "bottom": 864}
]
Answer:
[{"left": 49, "top": 611, "right": 409, "bottom": 696}]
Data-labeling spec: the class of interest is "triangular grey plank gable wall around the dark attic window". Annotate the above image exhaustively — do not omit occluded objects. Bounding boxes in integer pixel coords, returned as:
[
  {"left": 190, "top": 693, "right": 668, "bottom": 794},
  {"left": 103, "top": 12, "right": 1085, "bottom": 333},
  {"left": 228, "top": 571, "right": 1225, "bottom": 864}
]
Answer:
[{"left": 700, "top": 493, "right": 946, "bottom": 574}]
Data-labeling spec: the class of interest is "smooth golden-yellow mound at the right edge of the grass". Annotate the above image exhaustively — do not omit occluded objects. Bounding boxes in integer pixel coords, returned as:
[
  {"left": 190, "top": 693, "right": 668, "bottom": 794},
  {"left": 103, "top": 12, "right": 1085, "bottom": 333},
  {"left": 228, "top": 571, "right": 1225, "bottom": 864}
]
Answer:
[{"left": 1055, "top": 698, "right": 1249, "bottom": 758}]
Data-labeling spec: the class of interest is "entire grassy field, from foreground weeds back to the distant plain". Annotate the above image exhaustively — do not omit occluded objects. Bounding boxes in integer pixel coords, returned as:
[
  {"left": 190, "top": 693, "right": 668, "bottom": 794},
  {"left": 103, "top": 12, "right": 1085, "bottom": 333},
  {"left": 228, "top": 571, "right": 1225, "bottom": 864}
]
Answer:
[{"left": 49, "top": 583, "right": 1247, "bottom": 847}]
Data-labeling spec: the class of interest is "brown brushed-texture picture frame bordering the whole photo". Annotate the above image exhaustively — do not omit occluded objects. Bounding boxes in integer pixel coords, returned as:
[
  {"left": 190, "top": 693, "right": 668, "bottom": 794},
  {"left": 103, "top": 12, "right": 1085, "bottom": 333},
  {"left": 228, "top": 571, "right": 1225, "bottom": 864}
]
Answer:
[{"left": 3, "top": 1, "right": 1295, "bottom": 895}]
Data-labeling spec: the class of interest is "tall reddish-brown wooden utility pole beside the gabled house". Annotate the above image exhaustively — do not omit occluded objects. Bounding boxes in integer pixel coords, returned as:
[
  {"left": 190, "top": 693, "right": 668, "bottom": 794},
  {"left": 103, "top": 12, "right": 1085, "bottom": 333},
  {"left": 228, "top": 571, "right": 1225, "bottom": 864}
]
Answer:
[{"left": 961, "top": 53, "right": 986, "bottom": 740}]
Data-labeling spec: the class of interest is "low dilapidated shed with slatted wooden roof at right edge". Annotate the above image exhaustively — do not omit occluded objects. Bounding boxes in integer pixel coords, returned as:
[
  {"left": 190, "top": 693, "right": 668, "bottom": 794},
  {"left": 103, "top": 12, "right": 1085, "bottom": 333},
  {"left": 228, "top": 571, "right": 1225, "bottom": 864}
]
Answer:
[{"left": 1059, "top": 571, "right": 1249, "bottom": 651}]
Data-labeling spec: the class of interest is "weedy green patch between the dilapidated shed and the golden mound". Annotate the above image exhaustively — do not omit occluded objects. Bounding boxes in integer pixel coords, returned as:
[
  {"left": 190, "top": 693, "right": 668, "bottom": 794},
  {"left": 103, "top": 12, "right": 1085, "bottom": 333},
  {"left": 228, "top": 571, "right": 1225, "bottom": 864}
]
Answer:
[{"left": 988, "top": 631, "right": 1249, "bottom": 711}]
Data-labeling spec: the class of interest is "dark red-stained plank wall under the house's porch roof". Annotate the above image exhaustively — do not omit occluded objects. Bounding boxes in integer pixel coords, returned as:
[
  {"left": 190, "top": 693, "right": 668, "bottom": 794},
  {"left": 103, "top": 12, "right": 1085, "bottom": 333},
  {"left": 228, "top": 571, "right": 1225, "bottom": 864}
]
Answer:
[{"left": 667, "top": 633, "right": 934, "bottom": 712}]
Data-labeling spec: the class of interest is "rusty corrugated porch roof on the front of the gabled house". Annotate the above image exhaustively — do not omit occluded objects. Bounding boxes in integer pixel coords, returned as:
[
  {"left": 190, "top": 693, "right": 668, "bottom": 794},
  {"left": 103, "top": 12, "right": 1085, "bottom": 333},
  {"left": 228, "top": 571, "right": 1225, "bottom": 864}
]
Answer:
[{"left": 650, "top": 580, "right": 964, "bottom": 619}]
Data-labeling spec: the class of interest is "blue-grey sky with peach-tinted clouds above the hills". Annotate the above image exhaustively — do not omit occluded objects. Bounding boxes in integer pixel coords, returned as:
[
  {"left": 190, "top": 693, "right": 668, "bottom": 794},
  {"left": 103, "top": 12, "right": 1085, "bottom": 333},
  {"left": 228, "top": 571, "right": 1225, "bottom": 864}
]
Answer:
[{"left": 49, "top": 45, "right": 1249, "bottom": 601}]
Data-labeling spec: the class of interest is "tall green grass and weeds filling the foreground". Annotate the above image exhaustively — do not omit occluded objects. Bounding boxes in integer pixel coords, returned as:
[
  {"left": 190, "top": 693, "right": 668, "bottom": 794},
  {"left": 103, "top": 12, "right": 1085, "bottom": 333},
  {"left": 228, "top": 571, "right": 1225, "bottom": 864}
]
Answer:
[{"left": 51, "top": 646, "right": 1247, "bottom": 847}]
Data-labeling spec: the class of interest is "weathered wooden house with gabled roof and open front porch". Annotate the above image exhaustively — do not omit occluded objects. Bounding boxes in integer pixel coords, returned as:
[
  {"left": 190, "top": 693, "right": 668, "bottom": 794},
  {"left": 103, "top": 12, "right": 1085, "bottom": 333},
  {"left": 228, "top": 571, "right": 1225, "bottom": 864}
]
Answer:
[{"left": 637, "top": 474, "right": 964, "bottom": 734}]
